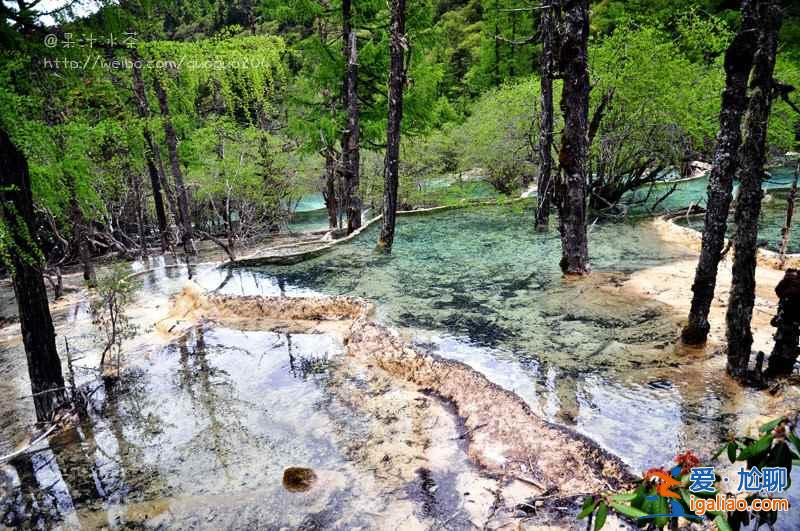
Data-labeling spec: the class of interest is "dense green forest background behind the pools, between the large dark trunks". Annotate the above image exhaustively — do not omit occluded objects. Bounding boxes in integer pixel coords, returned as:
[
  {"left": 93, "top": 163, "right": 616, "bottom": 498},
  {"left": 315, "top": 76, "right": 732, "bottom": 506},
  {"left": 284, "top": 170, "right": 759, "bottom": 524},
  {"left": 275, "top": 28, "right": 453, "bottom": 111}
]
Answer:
[{"left": 0, "top": 0, "right": 800, "bottom": 268}]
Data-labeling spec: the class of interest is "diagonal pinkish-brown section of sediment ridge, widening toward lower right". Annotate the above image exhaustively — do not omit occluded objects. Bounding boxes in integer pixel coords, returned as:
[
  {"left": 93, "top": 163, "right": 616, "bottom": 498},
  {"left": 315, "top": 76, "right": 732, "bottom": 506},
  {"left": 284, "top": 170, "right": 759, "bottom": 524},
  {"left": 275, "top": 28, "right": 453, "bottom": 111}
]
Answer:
[{"left": 347, "top": 317, "right": 634, "bottom": 495}]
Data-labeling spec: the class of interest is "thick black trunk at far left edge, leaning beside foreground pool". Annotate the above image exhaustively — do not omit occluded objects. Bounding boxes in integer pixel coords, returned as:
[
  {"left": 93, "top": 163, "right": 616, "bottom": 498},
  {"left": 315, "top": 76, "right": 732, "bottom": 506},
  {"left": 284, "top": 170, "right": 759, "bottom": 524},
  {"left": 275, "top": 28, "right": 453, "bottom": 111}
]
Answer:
[{"left": 0, "top": 129, "right": 67, "bottom": 421}]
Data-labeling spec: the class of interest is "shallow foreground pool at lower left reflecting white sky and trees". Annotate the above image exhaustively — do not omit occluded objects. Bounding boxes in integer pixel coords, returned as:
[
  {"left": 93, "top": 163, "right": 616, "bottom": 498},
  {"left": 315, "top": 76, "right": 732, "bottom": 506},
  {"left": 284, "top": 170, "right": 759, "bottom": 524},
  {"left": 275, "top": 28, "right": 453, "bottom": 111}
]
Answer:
[{"left": 0, "top": 326, "right": 478, "bottom": 529}]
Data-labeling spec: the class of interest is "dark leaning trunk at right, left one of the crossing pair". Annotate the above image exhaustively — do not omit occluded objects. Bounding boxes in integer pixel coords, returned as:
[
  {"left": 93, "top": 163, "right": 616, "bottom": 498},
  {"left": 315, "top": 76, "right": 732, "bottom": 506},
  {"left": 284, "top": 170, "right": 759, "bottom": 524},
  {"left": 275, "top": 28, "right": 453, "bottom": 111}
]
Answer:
[{"left": 681, "top": 0, "right": 760, "bottom": 345}]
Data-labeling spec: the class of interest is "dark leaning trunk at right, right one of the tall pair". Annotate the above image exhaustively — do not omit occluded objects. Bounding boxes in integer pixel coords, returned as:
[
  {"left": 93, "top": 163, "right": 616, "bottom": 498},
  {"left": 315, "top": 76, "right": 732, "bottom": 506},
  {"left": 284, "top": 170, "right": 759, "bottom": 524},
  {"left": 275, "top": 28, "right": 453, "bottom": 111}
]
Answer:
[{"left": 725, "top": 0, "right": 782, "bottom": 378}]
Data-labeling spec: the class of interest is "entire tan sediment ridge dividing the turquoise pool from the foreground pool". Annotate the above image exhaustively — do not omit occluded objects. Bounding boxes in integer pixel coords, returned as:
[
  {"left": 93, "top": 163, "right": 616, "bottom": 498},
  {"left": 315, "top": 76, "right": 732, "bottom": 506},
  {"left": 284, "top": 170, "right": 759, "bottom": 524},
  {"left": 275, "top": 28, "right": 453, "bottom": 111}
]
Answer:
[{"left": 166, "top": 285, "right": 635, "bottom": 496}]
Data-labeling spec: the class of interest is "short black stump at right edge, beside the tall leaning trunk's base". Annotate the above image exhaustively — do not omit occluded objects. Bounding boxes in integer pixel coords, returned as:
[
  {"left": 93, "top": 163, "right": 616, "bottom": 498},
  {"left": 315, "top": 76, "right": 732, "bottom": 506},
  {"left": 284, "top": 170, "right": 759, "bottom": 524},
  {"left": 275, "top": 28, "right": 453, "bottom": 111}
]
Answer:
[{"left": 766, "top": 269, "right": 800, "bottom": 376}]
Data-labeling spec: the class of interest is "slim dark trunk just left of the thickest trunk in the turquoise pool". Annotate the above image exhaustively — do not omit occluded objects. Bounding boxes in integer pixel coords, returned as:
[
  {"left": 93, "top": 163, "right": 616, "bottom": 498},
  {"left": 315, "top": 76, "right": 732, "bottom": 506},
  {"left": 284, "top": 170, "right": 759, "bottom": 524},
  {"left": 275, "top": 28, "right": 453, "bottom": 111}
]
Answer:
[{"left": 536, "top": 0, "right": 556, "bottom": 230}]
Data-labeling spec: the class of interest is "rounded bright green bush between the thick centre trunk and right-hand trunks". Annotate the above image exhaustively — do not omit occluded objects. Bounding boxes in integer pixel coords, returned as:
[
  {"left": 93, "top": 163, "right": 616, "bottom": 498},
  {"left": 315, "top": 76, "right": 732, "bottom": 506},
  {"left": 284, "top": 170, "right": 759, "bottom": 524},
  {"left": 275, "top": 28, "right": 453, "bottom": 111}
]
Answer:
[{"left": 590, "top": 19, "right": 728, "bottom": 156}]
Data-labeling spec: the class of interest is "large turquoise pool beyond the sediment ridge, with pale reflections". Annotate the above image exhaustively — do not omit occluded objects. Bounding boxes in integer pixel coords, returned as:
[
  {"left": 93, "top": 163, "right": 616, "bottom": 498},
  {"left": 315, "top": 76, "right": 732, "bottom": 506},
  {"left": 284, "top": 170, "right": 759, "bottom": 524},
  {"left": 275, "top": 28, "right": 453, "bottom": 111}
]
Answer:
[{"left": 189, "top": 206, "right": 758, "bottom": 470}]
